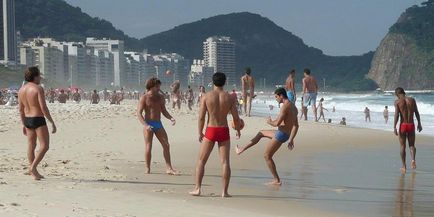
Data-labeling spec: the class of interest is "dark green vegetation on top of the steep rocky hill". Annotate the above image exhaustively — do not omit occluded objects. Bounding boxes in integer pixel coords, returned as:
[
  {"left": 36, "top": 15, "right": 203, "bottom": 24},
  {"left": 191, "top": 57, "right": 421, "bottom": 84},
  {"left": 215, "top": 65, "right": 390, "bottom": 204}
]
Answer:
[{"left": 390, "top": 0, "right": 434, "bottom": 52}]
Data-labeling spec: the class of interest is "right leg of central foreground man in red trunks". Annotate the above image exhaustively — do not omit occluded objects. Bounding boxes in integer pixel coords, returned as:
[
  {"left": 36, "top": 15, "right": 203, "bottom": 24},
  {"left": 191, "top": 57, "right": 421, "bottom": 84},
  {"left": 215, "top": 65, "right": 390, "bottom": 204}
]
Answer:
[{"left": 219, "top": 140, "right": 231, "bottom": 197}]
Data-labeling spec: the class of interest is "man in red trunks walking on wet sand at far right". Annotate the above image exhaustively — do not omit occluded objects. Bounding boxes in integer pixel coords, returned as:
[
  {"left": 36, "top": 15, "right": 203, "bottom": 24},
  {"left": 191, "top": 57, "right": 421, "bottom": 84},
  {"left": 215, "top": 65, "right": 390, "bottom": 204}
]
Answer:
[{"left": 393, "top": 87, "right": 422, "bottom": 173}]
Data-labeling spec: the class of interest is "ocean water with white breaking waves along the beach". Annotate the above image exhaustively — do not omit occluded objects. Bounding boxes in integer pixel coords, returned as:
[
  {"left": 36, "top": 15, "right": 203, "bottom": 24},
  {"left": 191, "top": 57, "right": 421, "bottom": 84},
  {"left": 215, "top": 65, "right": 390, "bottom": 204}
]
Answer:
[{"left": 252, "top": 93, "right": 434, "bottom": 135}]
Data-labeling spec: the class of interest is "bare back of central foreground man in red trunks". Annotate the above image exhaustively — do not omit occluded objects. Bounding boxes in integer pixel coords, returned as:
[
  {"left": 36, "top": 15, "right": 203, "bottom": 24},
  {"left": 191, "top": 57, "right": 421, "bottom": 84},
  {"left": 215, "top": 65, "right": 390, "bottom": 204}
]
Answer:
[{"left": 204, "top": 90, "right": 235, "bottom": 127}]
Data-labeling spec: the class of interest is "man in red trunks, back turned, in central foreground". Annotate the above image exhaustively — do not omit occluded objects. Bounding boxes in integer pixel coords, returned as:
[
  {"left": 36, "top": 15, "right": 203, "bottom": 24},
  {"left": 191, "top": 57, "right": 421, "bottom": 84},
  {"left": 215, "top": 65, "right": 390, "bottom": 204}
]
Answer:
[{"left": 190, "top": 72, "right": 240, "bottom": 197}]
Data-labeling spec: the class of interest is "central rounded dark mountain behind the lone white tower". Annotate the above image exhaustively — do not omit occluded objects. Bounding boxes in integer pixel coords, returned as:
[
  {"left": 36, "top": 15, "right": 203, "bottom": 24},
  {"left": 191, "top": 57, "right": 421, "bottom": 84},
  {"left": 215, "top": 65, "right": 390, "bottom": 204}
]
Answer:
[{"left": 141, "top": 12, "right": 376, "bottom": 90}]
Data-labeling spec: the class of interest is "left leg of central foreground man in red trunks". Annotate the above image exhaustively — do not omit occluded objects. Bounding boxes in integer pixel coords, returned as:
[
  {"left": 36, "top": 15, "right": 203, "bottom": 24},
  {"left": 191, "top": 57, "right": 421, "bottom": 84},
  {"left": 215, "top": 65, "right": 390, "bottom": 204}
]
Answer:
[{"left": 189, "top": 138, "right": 214, "bottom": 196}]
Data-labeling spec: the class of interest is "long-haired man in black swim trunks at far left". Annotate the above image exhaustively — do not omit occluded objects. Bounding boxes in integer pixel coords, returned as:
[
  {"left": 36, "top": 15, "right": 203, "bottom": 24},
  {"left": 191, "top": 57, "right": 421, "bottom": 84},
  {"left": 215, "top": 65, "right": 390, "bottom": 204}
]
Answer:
[{"left": 18, "top": 67, "right": 56, "bottom": 180}]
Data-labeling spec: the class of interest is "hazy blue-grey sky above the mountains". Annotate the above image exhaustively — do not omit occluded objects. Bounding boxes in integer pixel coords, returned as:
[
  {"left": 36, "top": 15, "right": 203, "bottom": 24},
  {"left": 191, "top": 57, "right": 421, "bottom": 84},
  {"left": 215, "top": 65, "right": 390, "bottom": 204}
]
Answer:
[{"left": 66, "top": 0, "right": 425, "bottom": 55}]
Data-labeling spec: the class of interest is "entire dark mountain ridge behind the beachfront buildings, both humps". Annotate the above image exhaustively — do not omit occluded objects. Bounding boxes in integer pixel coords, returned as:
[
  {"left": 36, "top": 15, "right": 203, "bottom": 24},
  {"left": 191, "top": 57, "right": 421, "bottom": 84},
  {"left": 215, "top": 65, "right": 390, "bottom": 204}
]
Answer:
[{"left": 16, "top": 0, "right": 376, "bottom": 90}]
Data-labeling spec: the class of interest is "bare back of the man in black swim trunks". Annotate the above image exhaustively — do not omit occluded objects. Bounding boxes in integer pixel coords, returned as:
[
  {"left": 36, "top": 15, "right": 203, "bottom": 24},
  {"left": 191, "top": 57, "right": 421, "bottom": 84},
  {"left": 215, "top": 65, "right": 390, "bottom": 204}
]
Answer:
[{"left": 18, "top": 82, "right": 44, "bottom": 117}]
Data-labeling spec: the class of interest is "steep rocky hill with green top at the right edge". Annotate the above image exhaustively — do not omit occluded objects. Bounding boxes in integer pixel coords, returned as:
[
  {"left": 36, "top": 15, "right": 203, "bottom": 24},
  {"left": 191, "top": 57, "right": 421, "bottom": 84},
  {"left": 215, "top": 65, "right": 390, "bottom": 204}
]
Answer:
[{"left": 368, "top": 0, "right": 434, "bottom": 90}]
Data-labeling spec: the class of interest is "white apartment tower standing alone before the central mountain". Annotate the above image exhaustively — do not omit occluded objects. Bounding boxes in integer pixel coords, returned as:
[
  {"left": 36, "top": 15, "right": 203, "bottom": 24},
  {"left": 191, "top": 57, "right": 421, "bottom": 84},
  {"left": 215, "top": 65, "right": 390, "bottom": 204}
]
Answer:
[{"left": 203, "top": 36, "right": 236, "bottom": 85}]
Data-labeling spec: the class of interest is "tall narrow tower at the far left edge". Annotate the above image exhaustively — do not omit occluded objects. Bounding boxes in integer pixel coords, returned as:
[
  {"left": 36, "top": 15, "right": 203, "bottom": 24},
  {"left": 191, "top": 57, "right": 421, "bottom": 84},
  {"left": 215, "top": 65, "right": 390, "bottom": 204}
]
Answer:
[{"left": 0, "top": 0, "right": 17, "bottom": 64}]
